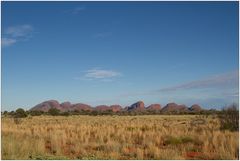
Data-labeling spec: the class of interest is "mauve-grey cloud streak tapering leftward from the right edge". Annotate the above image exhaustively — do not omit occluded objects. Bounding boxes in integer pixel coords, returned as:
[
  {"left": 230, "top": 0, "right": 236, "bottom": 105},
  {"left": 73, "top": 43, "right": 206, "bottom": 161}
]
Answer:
[{"left": 158, "top": 71, "right": 239, "bottom": 92}]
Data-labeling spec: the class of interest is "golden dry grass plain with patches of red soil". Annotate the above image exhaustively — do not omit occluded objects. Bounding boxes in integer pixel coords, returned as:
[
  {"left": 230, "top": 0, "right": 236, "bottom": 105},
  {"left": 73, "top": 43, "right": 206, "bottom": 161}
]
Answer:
[{"left": 2, "top": 115, "right": 239, "bottom": 159}]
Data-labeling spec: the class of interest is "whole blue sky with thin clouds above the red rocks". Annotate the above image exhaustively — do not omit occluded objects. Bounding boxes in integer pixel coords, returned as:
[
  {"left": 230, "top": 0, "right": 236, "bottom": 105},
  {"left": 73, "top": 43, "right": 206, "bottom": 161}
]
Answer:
[{"left": 1, "top": 2, "right": 239, "bottom": 110}]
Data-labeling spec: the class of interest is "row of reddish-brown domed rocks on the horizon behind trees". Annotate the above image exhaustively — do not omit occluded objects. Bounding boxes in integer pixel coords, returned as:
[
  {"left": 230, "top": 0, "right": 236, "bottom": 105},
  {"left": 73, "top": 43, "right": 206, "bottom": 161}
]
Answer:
[{"left": 30, "top": 100, "right": 202, "bottom": 113}]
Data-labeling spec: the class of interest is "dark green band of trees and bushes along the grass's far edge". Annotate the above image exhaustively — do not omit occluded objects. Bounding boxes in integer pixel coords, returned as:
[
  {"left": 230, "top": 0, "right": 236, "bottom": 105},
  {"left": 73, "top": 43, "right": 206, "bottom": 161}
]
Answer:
[{"left": 2, "top": 104, "right": 239, "bottom": 131}]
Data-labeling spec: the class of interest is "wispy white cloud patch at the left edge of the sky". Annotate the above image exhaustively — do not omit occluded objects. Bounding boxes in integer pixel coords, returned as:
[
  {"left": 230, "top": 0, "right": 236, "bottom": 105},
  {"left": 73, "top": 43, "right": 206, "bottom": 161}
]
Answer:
[{"left": 1, "top": 24, "right": 34, "bottom": 47}]
